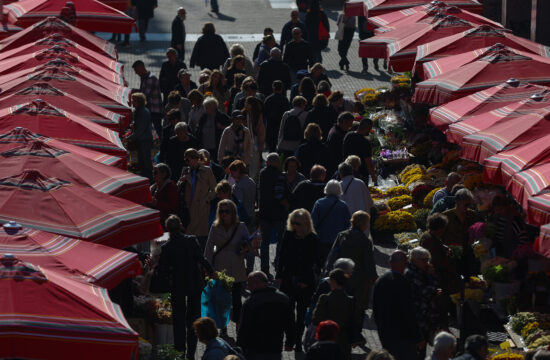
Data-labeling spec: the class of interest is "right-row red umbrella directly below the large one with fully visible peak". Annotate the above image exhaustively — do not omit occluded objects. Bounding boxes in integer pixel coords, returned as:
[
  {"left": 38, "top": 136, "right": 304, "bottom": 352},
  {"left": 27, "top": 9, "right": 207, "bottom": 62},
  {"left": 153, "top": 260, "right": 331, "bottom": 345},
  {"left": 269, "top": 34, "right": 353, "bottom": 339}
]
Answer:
[{"left": 429, "top": 79, "right": 548, "bottom": 131}]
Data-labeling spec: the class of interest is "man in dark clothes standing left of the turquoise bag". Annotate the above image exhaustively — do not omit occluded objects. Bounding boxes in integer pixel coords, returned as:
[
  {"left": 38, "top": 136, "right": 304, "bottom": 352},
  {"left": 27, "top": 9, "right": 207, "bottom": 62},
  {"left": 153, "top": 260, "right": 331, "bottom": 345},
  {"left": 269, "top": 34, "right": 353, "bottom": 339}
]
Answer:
[{"left": 157, "top": 215, "right": 214, "bottom": 359}]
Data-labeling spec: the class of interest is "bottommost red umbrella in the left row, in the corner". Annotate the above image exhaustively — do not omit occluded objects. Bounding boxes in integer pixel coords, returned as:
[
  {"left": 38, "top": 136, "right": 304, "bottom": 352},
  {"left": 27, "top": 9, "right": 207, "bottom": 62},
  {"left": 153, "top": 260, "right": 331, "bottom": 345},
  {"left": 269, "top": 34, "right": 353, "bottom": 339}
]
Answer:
[{"left": 0, "top": 255, "right": 138, "bottom": 360}]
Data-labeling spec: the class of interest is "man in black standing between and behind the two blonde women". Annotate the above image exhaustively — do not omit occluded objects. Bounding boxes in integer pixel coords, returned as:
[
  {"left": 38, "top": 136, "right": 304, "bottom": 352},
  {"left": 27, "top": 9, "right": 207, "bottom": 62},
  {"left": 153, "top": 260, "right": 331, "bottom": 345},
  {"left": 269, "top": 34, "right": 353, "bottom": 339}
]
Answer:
[{"left": 258, "top": 153, "right": 289, "bottom": 274}]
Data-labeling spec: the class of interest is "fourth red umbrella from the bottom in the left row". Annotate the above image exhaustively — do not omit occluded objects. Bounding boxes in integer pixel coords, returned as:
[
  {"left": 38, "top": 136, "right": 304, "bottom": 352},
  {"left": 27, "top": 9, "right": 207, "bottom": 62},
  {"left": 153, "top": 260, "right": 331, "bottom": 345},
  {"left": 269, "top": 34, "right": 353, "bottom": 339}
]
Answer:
[{"left": 0, "top": 140, "right": 152, "bottom": 204}]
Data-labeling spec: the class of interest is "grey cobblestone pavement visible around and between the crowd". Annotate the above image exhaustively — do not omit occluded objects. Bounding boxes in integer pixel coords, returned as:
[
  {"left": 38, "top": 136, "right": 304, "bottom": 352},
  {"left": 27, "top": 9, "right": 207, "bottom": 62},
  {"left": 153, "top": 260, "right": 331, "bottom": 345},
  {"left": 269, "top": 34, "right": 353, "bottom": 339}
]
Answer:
[{"left": 105, "top": 0, "right": 402, "bottom": 360}]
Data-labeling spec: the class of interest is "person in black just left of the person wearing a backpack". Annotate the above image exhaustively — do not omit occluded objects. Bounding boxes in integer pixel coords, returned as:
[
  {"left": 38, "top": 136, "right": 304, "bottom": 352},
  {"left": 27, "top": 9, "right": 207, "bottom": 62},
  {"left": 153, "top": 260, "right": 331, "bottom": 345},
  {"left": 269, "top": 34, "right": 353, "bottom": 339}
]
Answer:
[{"left": 264, "top": 80, "right": 290, "bottom": 151}]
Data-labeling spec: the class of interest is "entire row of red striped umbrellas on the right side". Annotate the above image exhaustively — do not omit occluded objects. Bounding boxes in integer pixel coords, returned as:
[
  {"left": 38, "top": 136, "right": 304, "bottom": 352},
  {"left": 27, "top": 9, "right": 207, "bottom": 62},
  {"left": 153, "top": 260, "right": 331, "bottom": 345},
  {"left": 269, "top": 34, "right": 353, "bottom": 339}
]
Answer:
[{"left": 354, "top": 0, "right": 550, "bottom": 256}]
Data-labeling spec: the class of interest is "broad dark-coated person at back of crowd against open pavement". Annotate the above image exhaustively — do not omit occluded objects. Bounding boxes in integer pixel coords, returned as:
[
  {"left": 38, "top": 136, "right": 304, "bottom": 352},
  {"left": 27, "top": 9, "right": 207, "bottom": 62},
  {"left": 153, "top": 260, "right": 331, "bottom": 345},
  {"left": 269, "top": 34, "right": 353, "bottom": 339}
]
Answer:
[{"left": 189, "top": 22, "right": 229, "bottom": 70}]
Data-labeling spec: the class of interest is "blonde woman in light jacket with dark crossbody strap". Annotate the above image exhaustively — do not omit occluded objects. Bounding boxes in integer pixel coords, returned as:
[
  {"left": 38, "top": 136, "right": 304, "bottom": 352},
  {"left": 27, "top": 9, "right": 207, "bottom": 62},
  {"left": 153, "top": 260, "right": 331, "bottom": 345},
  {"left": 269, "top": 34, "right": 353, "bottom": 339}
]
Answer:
[{"left": 204, "top": 199, "right": 248, "bottom": 325}]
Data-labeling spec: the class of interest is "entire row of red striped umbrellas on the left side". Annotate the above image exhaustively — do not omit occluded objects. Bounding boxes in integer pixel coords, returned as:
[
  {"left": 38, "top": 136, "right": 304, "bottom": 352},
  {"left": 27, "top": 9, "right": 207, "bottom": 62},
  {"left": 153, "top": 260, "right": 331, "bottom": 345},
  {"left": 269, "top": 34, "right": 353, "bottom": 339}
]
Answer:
[{"left": 0, "top": 14, "right": 156, "bottom": 359}]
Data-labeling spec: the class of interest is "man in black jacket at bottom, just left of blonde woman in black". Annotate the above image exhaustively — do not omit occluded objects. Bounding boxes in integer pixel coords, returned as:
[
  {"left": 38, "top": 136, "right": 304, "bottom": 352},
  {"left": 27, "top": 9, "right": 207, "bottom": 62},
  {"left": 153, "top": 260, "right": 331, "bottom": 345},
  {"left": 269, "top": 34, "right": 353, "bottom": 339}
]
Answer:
[{"left": 237, "top": 271, "right": 295, "bottom": 360}]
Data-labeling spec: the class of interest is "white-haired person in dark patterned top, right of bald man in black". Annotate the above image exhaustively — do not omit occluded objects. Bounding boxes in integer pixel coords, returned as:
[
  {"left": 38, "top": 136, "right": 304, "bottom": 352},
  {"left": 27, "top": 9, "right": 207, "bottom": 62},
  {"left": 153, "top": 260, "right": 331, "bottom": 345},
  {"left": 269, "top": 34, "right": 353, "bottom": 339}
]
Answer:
[{"left": 405, "top": 246, "right": 441, "bottom": 356}]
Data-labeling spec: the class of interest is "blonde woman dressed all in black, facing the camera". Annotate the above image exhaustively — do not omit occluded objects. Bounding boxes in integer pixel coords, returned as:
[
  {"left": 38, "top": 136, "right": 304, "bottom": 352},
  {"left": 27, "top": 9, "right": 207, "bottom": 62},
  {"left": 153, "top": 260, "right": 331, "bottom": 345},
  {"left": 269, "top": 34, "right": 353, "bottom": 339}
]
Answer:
[{"left": 276, "top": 209, "right": 320, "bottom": 351}]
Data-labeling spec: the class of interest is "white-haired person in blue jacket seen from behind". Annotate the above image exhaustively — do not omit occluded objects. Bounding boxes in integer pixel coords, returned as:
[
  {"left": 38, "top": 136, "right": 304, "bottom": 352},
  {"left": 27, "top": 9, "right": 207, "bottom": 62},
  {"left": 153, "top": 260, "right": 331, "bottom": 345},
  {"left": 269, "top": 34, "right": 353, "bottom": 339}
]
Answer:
[{"left": 311, "top": 180, "right": 351, "bottom": 264}]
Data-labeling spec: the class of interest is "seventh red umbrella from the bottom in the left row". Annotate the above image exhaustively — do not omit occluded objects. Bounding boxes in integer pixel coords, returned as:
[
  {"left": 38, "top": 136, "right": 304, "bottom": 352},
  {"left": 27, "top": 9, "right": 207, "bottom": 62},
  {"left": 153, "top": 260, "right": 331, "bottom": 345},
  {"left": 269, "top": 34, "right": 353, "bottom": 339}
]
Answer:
[{"left": 0, "top": 82, "right": 124, "bottom": 131}]
